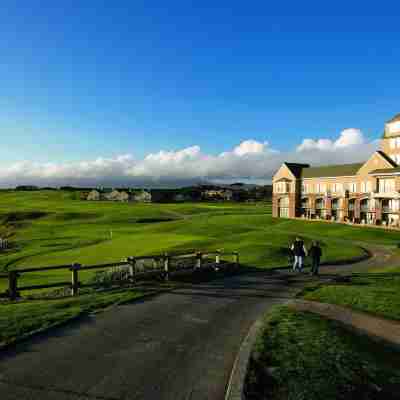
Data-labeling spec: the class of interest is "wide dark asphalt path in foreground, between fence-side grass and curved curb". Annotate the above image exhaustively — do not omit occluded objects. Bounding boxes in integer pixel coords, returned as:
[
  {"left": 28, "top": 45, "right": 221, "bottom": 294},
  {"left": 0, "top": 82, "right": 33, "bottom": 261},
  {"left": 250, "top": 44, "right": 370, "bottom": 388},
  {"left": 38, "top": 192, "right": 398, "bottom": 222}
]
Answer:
[{"left": 0, "top": 247, "right": 394, "bottom": 400}]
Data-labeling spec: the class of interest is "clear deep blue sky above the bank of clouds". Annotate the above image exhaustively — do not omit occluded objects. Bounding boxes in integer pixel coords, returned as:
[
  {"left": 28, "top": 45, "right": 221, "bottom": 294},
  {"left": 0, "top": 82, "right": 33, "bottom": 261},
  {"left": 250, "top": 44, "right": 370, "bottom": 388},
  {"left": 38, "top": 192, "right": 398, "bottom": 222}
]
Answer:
[{"left": 0, "top": 0, "right": 400, "bottom": 186}]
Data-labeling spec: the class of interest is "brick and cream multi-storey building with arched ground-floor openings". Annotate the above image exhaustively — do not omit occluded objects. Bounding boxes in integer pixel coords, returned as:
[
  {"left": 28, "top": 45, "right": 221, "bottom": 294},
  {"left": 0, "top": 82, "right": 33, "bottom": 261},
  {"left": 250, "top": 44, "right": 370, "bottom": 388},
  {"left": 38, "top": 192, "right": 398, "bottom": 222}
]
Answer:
[{"left": 272, "top": 114, "right": 400, "bottom": 226}]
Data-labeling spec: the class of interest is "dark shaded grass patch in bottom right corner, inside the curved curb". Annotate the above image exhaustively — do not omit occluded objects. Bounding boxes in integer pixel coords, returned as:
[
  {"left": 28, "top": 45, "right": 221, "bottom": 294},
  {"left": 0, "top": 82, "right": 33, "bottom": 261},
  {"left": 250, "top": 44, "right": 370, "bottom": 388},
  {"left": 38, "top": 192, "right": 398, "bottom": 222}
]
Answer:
[{"left": 245, "top": 307, "right": 400, "bottom": 400}]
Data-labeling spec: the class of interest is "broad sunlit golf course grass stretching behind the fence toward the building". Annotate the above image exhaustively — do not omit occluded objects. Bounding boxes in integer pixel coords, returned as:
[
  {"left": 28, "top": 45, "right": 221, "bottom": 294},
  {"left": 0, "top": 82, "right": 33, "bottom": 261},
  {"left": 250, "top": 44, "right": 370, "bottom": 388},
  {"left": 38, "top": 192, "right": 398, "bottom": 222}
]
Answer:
[{"left": 0, "top": 191, "right": 399, "bottom": 291}]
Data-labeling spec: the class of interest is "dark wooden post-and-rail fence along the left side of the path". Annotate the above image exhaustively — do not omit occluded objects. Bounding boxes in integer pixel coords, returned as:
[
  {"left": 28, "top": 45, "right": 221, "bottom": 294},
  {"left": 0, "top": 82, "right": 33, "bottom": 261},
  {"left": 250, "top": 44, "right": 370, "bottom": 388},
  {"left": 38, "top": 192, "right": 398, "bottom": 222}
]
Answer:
[{"left": 0, "top": 251, "right": 239, "bottom": 300}]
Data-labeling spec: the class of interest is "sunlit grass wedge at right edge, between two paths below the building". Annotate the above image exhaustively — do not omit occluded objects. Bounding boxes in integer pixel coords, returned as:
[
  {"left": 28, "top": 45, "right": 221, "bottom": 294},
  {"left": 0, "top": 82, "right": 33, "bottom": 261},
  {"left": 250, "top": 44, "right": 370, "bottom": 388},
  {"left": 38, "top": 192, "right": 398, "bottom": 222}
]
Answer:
[{"left": 302, "top": 267, "right": 400, "bottom": 320}]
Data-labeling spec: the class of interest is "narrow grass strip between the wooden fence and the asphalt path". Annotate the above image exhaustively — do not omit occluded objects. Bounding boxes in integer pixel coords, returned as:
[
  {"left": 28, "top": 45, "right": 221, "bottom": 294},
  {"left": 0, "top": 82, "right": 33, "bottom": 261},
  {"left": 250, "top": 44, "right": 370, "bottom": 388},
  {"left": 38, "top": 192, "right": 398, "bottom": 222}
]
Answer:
[{"left": 0, "top": 289, "right": 142, "bottom": 347}]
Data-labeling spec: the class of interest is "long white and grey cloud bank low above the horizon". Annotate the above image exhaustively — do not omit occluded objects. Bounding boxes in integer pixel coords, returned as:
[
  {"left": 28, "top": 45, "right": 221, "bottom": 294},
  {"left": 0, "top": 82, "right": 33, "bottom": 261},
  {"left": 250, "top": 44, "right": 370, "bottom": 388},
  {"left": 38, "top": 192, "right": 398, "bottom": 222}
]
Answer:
[{"left": 0, "top": 128, "right": 379, "bottom": 187}]
